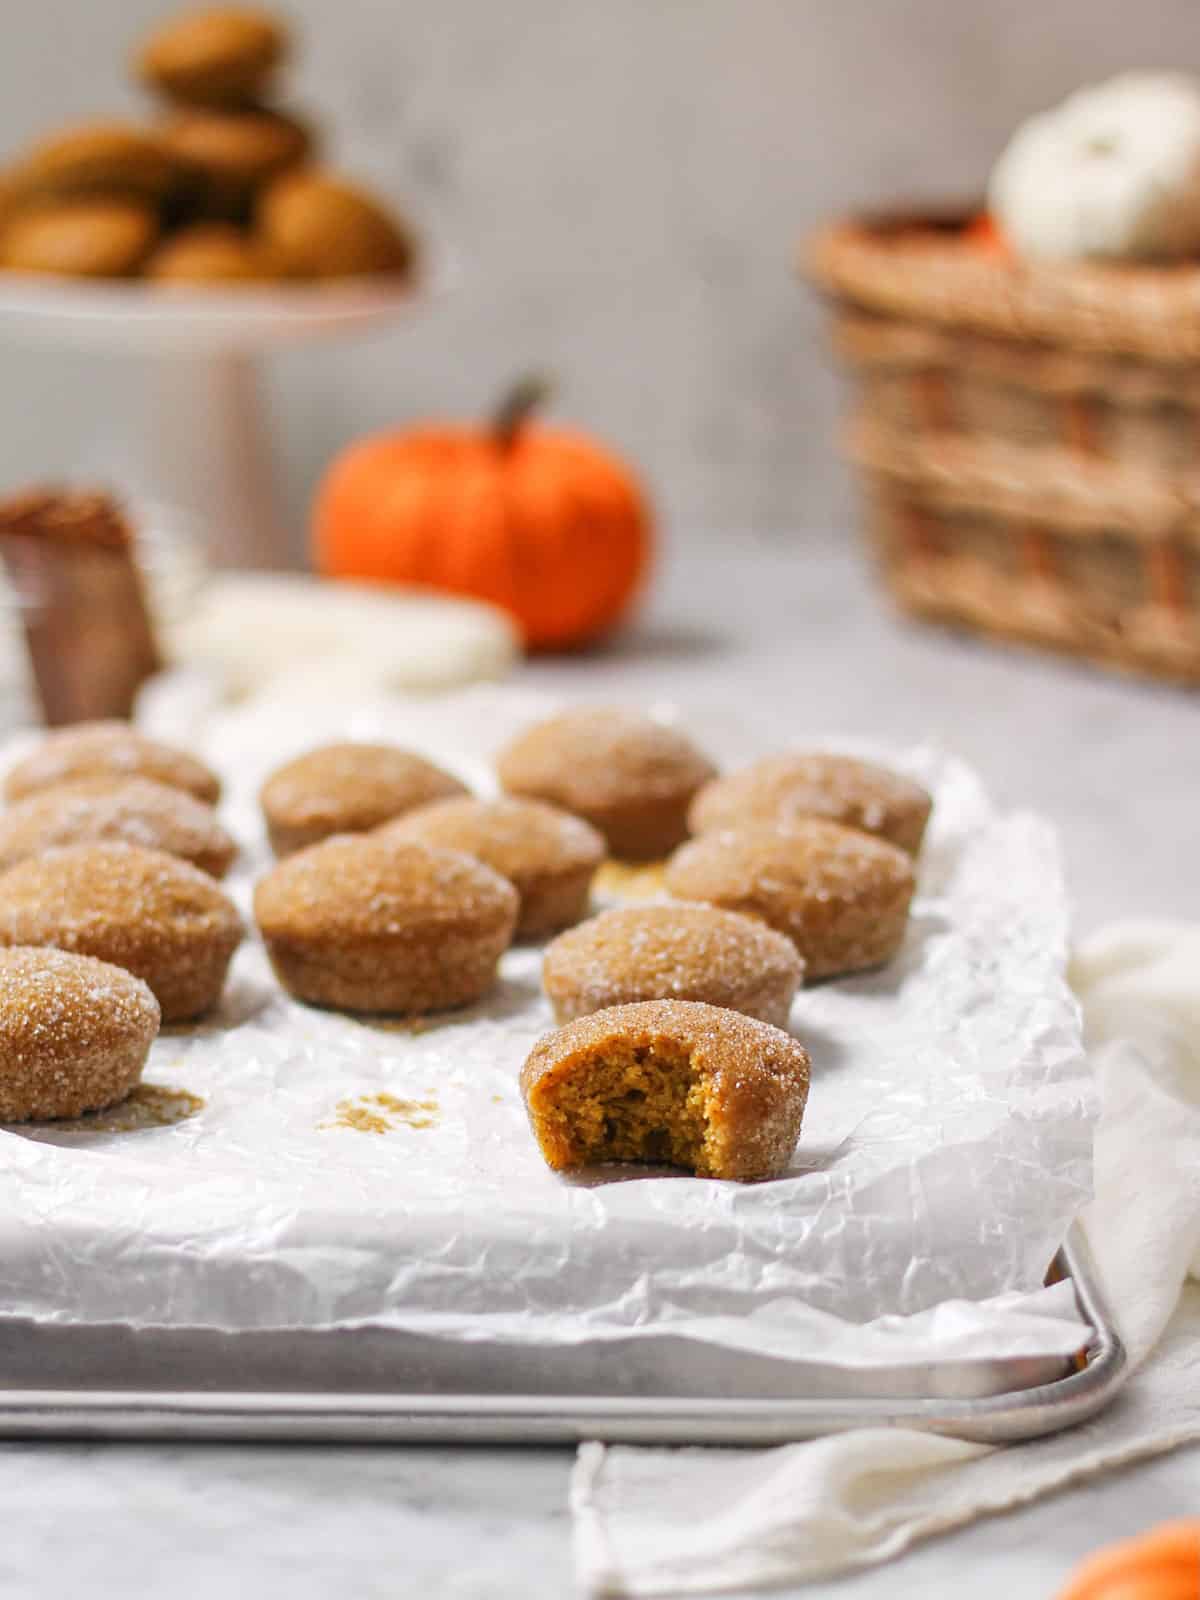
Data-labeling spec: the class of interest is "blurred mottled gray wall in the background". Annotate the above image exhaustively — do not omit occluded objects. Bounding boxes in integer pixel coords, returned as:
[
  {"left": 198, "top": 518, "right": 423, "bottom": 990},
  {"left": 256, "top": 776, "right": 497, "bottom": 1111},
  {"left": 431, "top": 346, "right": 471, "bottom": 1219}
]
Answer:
[{"left": 0, "top": 0, "right": 1200, "bottom": 566}]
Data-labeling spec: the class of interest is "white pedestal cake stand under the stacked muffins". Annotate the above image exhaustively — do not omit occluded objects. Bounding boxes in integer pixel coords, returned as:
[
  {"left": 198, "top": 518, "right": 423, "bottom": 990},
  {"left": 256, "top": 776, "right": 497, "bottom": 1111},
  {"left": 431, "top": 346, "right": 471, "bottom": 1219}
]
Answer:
[{"left": 0, "top": 261, "right": 454, "bottom": 566}]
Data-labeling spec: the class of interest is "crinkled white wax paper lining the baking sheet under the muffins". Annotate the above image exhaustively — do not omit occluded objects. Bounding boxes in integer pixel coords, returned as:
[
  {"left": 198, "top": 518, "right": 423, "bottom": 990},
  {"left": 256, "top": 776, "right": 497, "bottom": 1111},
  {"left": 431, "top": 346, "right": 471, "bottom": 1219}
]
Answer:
[{"left": 0, "top": 688, "right": 1093, "bottom": 1366}]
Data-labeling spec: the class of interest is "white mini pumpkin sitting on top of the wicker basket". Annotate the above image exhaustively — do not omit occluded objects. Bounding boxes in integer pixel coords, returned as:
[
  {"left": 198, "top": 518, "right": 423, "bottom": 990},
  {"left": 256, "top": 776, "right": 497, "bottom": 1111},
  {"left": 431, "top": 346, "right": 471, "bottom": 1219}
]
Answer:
[{"left": 987, "top": 72, "right": 1200, "bottom": 261}]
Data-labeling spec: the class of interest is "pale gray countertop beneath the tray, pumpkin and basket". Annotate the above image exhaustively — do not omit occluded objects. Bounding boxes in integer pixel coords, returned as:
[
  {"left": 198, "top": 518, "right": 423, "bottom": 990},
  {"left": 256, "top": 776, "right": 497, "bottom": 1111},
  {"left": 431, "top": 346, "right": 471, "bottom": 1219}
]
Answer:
[{"left": 0, "top": 538, "right": 1200, "bottom": 1600}]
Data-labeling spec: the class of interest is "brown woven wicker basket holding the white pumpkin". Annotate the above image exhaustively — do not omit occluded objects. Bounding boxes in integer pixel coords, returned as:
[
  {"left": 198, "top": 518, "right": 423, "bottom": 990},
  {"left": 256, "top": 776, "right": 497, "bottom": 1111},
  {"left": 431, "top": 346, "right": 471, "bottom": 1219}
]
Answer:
[{"left": 808, "top": 218, "right": 1200, "bottom": 683}]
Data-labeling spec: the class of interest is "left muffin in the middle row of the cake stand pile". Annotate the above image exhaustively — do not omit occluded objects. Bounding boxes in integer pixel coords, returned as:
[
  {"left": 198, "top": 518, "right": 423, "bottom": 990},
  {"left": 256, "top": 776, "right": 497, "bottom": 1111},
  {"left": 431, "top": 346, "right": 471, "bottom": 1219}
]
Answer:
[{"left": 14, "top": 122, "right": 179, "bottom": 206}]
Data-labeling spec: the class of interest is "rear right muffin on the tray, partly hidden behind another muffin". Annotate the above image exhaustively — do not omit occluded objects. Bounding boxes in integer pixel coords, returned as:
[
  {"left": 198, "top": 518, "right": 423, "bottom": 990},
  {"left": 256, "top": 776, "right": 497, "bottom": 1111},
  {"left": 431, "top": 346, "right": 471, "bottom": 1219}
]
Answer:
[{"left": 688, "top": 754, "right": 933, "bottom": 856}]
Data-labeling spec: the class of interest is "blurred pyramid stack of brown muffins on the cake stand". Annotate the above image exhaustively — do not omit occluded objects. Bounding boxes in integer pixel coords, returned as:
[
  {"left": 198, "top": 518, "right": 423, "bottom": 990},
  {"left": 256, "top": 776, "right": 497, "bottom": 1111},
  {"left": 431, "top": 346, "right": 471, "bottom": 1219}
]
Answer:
[{"left": 0, "top": 8, "right": 416, "bottom": 285}]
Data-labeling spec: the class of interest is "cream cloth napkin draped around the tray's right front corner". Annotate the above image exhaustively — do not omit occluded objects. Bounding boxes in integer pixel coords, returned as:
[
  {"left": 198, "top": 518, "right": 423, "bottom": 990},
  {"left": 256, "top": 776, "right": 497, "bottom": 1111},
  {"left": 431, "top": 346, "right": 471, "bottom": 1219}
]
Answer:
[{"left": 571, "top": 922, "right": 1200, "bottom": 1595}]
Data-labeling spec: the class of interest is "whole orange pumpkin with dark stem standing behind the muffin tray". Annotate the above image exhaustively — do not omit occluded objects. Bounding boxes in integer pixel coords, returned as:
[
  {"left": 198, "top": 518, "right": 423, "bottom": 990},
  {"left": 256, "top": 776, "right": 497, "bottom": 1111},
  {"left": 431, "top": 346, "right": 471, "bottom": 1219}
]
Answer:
[{"left": 314, "top": 381, "right": 651, "bottom": 650}]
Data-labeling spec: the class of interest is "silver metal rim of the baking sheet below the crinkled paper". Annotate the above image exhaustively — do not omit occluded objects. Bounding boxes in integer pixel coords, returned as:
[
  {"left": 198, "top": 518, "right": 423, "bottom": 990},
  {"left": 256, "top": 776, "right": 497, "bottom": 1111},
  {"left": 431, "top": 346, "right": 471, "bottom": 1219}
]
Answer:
[{"left": 0, "top": 1229, "right": 1126, "bottom": 1445}]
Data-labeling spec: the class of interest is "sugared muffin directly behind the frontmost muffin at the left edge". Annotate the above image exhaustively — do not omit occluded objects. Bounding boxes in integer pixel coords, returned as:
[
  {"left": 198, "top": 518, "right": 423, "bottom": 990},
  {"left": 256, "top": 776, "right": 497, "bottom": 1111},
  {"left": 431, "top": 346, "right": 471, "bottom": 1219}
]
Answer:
[{"left": 0, "top": 843, "right": 242, "bottom": 1022}]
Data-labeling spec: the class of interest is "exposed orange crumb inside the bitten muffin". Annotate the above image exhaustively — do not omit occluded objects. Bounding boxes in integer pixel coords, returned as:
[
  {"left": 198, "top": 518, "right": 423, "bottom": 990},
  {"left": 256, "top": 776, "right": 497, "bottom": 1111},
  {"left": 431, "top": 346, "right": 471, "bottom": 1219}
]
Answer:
[{"left": 538, "top": 1040, "right": 709, "bottom": 1173}]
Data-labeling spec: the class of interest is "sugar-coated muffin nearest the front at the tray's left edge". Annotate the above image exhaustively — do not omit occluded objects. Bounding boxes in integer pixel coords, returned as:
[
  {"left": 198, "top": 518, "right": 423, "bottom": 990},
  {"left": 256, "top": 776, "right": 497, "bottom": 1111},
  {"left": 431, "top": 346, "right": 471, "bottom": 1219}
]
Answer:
[{"left": 0, "top": 946, "right": 160, "bottom": 1122}]
